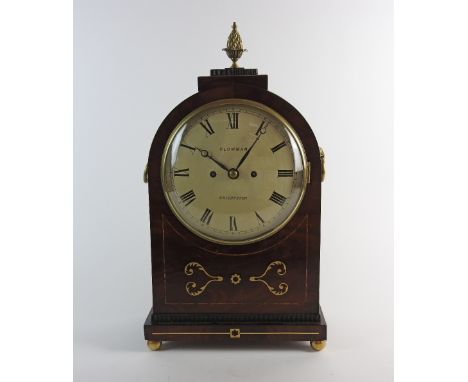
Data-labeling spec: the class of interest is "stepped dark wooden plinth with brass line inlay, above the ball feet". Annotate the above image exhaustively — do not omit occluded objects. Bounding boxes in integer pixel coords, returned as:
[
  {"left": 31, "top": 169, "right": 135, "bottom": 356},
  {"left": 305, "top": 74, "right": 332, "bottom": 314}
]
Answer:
[{"left": 144, "top": 310, "right": 327, "bottom": 342}]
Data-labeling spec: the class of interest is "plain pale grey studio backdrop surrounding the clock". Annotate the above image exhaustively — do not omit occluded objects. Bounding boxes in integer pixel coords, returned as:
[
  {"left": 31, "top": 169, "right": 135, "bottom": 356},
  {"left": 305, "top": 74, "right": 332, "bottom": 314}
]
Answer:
[{"left": 74, "top": 0, "right": 393, "bottom": 382}]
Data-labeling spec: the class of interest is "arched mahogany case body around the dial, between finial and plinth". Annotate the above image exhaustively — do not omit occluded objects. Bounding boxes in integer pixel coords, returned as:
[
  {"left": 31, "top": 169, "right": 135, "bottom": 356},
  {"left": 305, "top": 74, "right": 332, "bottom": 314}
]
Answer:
[{"left": 147, "top": 75, "right": 323, "bottom": 324}]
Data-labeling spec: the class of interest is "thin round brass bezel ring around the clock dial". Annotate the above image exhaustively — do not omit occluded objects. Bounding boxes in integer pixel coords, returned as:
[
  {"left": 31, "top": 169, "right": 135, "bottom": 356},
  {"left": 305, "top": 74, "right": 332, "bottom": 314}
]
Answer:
[{"left": 161, "top": 98, "right": 308, "bottom": 245}]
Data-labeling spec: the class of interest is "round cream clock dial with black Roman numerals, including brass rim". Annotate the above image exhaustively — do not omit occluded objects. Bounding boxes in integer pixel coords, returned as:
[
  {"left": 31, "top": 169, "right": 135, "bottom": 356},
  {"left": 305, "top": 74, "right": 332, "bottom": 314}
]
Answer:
[{"left": 161, "top": 99, "right": 307, "bottom": 245}]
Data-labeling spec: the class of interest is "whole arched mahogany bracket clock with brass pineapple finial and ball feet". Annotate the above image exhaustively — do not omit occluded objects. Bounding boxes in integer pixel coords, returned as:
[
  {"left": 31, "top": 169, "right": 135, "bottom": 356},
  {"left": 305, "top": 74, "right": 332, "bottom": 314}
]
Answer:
[{"left": 144, "top": 23, "right": 327, "bottom": 350}]
